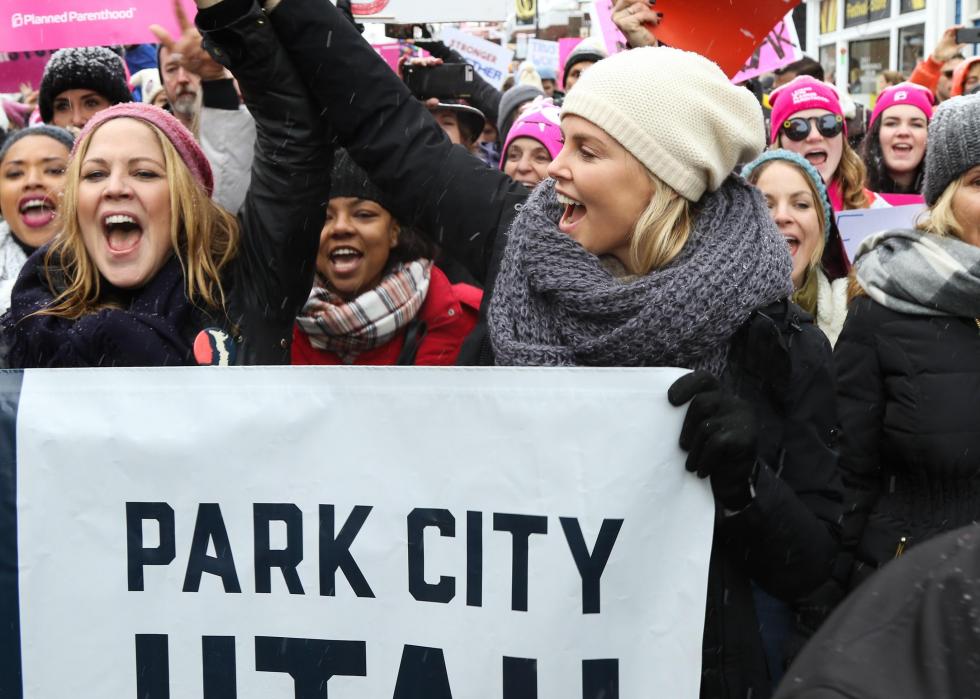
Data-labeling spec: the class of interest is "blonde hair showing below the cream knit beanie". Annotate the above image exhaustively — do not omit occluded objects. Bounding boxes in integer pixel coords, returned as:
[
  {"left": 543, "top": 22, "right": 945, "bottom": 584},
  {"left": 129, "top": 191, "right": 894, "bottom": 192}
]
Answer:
[{"left": 630, "top": 170, "right": 692, "bottom": 275}]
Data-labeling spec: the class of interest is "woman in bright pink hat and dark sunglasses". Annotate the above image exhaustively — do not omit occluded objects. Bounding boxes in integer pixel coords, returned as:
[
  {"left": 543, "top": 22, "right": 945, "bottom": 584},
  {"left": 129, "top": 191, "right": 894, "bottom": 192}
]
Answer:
[{"left": 769, "top": 75, "right": 888, "bottom": 211}]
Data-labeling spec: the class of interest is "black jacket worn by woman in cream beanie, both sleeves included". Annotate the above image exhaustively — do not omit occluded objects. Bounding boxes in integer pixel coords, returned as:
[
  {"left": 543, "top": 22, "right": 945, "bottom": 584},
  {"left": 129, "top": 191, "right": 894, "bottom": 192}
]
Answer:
[{"left": 270, "top": 6, "right": 841, "bottom": 699}]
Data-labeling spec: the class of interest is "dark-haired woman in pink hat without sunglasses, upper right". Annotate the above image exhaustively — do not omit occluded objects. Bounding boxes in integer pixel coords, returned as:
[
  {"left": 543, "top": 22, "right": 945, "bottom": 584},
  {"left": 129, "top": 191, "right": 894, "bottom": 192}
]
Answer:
[{"left": 861, "top": 82, "right": 935, "bottom": 205}]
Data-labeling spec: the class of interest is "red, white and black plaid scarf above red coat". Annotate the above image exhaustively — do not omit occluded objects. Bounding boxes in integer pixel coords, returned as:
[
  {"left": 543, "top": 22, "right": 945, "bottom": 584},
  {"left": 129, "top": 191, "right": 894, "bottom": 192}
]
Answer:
[{"left": 296, "top": 259, "right": 432, "bottom": 364}]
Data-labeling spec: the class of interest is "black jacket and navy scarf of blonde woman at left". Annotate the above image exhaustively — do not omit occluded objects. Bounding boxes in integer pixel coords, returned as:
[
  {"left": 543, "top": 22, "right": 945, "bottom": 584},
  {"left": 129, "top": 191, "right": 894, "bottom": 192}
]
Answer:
[{"left": 0, "top": 0, "right": 333, "bottom": 368}]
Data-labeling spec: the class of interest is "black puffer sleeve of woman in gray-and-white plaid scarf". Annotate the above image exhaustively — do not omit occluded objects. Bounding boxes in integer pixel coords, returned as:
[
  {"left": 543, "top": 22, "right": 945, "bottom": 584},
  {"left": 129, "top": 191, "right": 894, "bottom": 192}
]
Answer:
[{"left": 834, "top": 297, "right": 885, "bottom": 587}]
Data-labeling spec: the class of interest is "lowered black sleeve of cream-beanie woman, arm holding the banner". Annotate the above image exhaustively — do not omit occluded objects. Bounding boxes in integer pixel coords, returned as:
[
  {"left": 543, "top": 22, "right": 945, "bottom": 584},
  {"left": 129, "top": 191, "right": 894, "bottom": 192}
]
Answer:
[{"left": 719, "top": 307, "right": 842, "bottom": 601}]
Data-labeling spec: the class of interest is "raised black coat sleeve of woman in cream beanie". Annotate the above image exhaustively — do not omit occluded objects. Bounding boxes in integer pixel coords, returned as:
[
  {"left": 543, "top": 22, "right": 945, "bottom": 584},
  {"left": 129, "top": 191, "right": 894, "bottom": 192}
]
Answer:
[{"left": 271, "top": 0, "right": 523, "bottom": 281}]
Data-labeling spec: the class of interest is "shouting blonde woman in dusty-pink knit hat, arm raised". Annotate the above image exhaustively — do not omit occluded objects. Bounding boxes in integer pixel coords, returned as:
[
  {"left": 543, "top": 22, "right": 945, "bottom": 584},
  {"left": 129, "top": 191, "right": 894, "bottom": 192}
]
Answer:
[{"left": 0, "top": 2, "right": 332, "bottom": 368}]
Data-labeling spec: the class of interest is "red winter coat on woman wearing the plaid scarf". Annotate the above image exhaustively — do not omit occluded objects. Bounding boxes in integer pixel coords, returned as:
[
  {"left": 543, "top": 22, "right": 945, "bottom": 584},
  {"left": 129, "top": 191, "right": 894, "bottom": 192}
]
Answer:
[{"left": 292, "top": 266, "right": 483, "bottom": 366}]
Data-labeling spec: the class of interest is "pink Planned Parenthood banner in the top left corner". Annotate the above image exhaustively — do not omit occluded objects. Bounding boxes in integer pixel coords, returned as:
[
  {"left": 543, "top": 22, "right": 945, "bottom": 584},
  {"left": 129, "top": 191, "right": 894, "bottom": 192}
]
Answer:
[{"left": 0, "top": 0, "right": 197, "bottom": 53}]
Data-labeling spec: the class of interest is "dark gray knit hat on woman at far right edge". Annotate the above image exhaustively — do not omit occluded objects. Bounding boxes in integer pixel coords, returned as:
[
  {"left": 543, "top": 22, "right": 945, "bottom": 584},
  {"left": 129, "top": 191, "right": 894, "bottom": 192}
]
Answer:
[{"left": 922, "top": 95, "right": 980, "bottom": 206}]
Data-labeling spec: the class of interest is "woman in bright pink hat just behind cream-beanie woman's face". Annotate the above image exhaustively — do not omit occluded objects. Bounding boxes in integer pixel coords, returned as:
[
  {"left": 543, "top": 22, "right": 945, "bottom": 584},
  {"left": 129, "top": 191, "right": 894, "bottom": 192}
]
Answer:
[{"left": 500, "top": 99, "right": 561, "bottom": 189}]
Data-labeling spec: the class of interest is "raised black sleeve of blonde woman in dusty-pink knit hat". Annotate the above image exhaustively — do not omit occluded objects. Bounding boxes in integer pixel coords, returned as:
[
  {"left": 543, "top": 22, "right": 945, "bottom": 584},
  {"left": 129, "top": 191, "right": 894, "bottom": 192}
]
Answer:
[{"left": 197, "top": 0, "right": 333, "bottom": 364}]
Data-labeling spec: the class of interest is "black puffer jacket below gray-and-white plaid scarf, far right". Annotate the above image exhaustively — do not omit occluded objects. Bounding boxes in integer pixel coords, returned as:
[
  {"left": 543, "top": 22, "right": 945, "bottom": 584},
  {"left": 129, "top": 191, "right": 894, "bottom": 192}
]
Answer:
[{"left": 834, "top": 296, "right": 980, "bottom": 588}]
